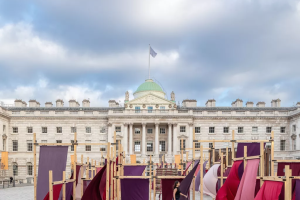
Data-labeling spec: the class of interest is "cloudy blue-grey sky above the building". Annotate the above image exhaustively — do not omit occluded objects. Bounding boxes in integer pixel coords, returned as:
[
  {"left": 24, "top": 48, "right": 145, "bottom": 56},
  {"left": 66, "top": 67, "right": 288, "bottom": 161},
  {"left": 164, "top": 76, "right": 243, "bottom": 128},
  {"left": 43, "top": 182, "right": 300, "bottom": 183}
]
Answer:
[{"left": 0, "top": 0, "right": 300, "bottom": 106}]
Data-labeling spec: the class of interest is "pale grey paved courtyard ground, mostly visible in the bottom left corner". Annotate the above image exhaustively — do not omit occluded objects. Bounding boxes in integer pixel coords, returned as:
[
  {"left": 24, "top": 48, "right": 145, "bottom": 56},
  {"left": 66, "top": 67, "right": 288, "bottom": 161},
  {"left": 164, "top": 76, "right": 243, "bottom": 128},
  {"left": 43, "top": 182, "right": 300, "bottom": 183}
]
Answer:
[{"left": 0, "top": 186, "right": 212, "bottom": 200}]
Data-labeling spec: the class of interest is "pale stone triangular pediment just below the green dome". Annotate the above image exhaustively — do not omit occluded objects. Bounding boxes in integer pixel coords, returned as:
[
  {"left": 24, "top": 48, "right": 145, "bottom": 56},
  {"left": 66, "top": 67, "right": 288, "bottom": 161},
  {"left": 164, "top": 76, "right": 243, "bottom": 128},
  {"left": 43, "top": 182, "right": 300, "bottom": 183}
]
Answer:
[{"left": 126, "top": 93, "right": 174, "bottom": 105}]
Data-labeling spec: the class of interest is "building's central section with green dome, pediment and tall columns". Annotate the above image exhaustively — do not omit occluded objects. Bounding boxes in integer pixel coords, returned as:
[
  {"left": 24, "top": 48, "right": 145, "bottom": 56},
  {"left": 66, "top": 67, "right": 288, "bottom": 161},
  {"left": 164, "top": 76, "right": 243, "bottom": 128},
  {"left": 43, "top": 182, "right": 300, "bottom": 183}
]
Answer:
[{"left": 108, "top": 79, "right": 193, "bottom": 162}]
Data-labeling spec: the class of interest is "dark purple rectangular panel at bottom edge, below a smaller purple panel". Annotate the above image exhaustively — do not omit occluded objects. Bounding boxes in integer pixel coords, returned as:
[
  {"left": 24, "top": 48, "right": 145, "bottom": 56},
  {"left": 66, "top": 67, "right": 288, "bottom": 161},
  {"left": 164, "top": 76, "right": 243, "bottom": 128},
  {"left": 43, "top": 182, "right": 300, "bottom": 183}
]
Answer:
[{"left": 121, "top": 179, "right": 149, "bottom": 200}]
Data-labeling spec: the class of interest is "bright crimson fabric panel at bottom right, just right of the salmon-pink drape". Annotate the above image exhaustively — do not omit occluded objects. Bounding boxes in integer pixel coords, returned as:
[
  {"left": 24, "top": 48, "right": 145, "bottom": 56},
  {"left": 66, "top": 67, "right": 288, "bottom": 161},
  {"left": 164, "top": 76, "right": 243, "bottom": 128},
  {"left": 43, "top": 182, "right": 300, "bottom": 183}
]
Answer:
[{"left": 254, "top": 181, "right": 283, "bottom": 200}]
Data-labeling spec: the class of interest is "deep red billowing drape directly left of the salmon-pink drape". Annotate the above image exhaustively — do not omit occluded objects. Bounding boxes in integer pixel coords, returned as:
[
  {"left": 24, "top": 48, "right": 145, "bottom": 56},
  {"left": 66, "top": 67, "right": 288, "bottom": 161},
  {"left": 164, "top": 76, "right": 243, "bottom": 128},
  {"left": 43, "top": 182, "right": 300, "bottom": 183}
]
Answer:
[{"left": 216, "top": 160, "right": 242, "bottom": 200}]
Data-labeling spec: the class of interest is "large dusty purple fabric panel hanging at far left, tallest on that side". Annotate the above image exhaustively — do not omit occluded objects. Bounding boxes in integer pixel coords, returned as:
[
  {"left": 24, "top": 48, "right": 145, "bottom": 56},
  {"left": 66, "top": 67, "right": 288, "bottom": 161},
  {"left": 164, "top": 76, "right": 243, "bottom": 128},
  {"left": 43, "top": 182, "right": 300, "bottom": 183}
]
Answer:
[{"left": 36, "top": 146, "right": 68, "bottom": 200}]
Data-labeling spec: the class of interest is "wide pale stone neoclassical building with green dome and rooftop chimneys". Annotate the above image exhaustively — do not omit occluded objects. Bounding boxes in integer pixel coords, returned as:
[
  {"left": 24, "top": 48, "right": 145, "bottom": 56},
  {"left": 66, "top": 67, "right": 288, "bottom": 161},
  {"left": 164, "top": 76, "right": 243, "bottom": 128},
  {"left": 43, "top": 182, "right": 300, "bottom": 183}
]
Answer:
[{"left": 0, "top": 79, "right": 300, "bottom": 181}]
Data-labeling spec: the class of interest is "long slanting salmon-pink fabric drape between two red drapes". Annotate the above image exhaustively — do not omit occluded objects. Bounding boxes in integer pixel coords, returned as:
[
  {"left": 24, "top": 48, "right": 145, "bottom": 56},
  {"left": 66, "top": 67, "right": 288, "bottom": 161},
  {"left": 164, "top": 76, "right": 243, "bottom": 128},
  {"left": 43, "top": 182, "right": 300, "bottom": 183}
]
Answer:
[{"left": 234, "top": 159, "right": 259, "bottom": 200}]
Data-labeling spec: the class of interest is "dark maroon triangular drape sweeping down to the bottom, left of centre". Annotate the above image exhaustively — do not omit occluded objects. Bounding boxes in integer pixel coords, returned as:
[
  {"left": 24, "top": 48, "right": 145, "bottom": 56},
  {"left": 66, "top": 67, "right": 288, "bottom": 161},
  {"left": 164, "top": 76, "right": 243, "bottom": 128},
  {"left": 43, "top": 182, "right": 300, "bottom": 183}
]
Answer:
[{"left": 81, "top": 165, "right": 106, "bottom": 200}]
